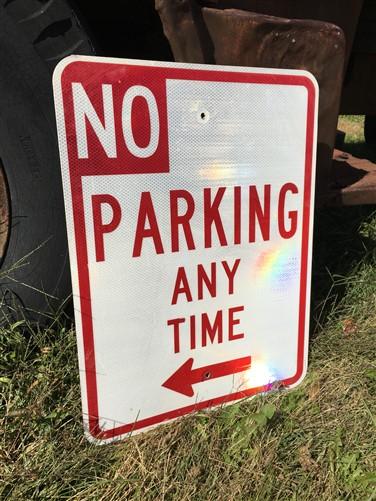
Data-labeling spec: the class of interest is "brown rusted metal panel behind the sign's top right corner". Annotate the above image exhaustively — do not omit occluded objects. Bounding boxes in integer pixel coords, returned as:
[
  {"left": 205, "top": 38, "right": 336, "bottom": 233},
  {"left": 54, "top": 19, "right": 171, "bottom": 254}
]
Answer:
[{"left": 156, "top": 0, "right": 345, "bottom": 204}]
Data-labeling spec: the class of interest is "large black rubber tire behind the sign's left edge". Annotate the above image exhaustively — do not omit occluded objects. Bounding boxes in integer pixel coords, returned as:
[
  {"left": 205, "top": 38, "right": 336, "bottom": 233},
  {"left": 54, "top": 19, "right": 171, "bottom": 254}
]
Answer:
[{"left": 0, "top": 0, "right": 93, "bottom": 323}]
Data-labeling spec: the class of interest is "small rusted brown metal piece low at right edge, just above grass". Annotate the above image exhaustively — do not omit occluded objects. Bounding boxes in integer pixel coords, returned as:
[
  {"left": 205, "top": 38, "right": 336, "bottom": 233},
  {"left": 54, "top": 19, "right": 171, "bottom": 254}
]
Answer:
[{"left": 330, "top": 149, "right": 376, "bottom": 205}]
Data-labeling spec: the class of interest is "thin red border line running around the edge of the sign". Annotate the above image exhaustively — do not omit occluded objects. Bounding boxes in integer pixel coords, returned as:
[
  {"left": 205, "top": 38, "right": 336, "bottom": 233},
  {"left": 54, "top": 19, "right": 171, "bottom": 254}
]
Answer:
[{"left": 61, "top": 60, "right": 316, "bottom": 440}]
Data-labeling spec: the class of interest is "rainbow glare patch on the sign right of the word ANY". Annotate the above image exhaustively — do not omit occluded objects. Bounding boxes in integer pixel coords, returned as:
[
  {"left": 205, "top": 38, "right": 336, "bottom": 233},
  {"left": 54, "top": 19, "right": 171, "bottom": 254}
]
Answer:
[{"left": 253, "top": 244, "right": 299, "bottom": 289}]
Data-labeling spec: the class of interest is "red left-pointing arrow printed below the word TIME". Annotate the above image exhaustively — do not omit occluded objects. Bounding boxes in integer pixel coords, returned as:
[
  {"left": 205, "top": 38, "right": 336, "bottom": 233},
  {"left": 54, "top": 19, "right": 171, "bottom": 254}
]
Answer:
[{"left": 162, "top": 357, "right": 251, "bottom": 397}]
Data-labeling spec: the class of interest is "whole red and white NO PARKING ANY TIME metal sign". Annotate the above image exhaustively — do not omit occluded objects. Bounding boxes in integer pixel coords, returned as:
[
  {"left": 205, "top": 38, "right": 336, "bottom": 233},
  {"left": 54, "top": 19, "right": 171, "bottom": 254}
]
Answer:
[{"left": 54, "top": 56, "right": 318, "bottom": 441}]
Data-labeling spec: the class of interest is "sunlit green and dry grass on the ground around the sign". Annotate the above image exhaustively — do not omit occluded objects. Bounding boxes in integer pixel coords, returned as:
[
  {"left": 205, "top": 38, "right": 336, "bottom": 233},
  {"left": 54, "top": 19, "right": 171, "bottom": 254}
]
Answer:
[{"left": 0, "top": 119, "right": 376, "bottom": 501}]
